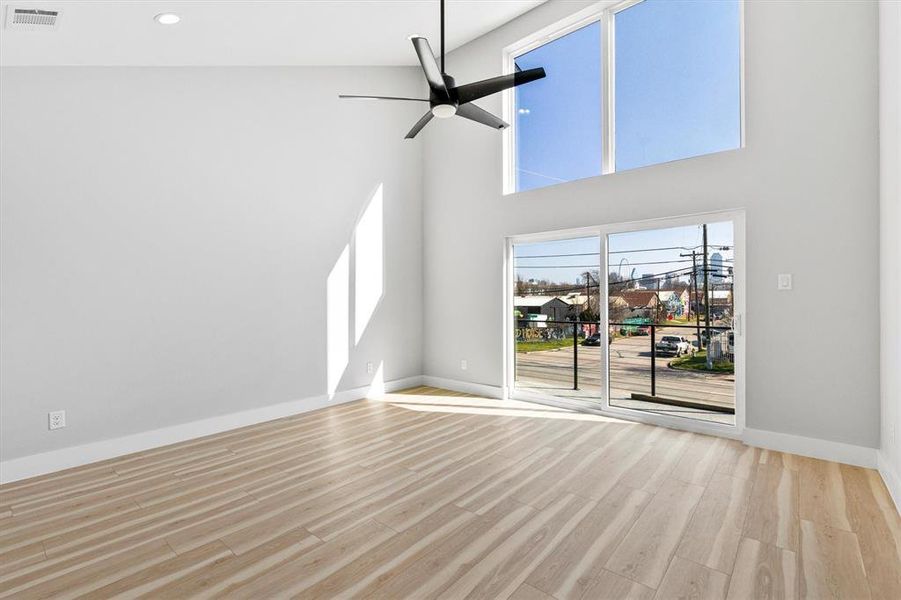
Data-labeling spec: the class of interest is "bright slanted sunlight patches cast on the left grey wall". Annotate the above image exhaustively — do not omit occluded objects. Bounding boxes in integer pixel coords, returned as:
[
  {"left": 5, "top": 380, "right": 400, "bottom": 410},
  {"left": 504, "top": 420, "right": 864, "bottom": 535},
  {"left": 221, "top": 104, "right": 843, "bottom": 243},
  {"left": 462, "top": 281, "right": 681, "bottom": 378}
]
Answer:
[{"left": 325, "top": 183, "right": 385, "bottom": 400}]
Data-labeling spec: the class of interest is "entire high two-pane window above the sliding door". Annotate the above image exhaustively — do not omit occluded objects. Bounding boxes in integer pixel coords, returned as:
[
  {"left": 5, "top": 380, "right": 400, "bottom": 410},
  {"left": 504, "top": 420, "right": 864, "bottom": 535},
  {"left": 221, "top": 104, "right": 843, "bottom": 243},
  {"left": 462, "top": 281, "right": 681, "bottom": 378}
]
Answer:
[{"left": 505, "top": 0, "right": 742, "bottom": 192}]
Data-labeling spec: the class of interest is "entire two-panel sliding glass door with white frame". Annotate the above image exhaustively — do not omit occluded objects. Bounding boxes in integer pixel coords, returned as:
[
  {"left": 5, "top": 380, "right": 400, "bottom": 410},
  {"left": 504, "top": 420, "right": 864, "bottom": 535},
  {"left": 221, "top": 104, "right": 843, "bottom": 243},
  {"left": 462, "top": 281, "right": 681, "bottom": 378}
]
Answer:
[{"left": 507, "top": 213, "right": 743, "bottom": 427}]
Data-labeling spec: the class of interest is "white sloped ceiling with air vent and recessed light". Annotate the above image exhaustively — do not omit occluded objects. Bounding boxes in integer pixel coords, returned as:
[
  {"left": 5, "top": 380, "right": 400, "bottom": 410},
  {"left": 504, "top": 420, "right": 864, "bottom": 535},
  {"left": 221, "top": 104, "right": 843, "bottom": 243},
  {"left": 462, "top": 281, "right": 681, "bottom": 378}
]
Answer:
[{"left": 0, "top": 0, "right": 545, "bottom": 66}]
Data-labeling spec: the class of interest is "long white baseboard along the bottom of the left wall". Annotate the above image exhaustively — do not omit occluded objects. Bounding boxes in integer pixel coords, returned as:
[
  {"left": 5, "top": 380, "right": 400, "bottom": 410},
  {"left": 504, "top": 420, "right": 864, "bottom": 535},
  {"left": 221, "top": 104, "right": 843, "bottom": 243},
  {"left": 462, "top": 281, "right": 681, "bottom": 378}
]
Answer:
[{"left": 0, "top": 376, "right": 422, "bottom": 483}]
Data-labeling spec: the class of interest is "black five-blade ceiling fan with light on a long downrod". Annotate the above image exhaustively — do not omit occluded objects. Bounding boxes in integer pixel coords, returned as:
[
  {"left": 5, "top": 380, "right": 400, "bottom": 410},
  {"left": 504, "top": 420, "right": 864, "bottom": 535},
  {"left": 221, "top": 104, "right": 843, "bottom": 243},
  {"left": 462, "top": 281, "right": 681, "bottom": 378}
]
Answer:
[{"left": 338, "top": 0, "right": 545, "bottom": 140}]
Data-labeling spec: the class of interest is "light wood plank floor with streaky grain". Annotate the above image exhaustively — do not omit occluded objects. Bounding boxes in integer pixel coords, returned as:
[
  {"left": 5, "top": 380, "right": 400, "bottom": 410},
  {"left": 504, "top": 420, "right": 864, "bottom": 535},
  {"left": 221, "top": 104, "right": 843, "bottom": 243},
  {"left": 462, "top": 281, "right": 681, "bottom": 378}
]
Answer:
[{"left": 0, "top": 388, "right": 901, "bottom": 600}]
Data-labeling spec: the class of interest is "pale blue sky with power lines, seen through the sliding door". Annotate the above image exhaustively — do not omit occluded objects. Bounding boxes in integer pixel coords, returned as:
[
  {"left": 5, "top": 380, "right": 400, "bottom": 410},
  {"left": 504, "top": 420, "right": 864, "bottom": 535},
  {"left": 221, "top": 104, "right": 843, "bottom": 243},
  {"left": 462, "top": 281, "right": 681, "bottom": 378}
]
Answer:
[{"left": 514, "top": 222, "right": 734, "bottom": 283}]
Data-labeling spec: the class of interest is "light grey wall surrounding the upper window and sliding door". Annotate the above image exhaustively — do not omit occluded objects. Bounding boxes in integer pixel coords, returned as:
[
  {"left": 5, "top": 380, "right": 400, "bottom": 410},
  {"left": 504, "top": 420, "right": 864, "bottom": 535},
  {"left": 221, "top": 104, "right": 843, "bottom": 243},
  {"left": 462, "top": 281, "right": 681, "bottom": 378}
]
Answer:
[{"left": 423, "top": 0, "right": 879, "bottom": 448}]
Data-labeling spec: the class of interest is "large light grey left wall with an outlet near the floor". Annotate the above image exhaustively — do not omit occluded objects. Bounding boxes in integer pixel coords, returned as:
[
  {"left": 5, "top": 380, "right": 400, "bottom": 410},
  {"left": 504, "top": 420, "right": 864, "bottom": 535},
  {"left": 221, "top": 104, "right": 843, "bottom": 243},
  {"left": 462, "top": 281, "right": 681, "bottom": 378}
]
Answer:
[{"left": 0, "top": 67, "right": 422, "bottom": 461}]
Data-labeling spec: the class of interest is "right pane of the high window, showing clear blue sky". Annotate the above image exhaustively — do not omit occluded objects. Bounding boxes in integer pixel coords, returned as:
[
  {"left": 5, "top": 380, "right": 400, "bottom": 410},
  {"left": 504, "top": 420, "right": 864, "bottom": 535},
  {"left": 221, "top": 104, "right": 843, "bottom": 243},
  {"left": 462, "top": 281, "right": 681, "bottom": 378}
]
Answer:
[{"left": 614, "top": 0, "right": 741, "bottom": 170}]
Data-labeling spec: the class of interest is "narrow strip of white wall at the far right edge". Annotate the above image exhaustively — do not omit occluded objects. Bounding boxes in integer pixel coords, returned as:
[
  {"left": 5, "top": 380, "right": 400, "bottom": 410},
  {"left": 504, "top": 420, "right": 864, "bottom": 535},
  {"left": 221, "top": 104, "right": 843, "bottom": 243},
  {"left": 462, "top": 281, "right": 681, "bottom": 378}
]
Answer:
[{"left": 879, "top": 0, "right": 901, "bottom": 507}]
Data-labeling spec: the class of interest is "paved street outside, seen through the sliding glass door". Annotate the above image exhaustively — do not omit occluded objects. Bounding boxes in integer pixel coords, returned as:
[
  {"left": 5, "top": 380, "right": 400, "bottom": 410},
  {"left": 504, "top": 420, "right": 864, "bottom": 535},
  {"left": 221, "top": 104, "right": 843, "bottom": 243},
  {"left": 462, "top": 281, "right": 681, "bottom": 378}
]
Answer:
[{"left": 516, "top": 328, "right": 735, "bottom": 408}]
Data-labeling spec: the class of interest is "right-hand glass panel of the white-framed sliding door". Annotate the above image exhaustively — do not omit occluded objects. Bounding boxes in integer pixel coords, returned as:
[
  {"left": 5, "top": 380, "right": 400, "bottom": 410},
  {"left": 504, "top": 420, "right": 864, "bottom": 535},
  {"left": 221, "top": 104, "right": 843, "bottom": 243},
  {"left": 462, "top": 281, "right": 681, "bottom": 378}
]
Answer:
[{"left": 606, "top": 221, "right": 736, "bottom": 425}]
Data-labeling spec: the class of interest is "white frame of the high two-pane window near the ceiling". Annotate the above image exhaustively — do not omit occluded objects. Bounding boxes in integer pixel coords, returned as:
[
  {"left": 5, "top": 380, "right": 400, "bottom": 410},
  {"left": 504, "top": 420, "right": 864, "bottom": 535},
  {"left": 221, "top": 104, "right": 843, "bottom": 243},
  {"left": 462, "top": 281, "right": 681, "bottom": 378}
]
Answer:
[{"left": 502, "top": 0, "right": 745, "bottom": 195}]
